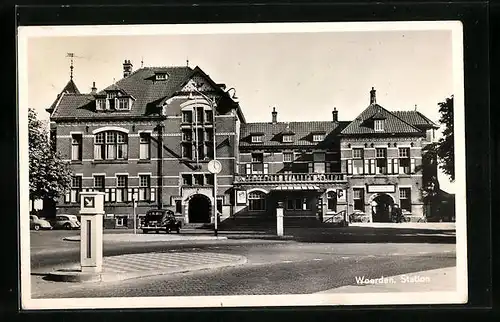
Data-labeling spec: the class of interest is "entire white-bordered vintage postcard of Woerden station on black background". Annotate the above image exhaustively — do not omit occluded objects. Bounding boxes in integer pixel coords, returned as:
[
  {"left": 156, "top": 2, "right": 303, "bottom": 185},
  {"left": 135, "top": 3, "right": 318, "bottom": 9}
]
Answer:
[{"left": 17, "top": 21, "right": 468, "bottom": 310}]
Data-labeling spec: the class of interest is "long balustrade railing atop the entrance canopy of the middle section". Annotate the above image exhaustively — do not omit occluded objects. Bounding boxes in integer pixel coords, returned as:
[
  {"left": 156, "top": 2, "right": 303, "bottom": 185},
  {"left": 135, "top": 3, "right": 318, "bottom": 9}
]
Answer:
[{"left": 236, "top": 173, "right": 346, "bottom": 183}]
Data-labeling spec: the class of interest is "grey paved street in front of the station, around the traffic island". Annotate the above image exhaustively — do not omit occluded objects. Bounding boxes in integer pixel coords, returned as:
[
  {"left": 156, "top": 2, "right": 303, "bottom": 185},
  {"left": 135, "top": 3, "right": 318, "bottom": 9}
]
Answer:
[{"left": 31, "top": 232, "right": 455, "bottom": 298}]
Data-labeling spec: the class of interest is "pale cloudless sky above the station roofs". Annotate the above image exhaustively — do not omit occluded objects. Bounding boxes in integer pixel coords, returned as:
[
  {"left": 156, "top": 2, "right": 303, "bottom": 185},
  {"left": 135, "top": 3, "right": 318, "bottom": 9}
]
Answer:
[{"left": 27, "top": 25, "right": 454, "bottom": 192}]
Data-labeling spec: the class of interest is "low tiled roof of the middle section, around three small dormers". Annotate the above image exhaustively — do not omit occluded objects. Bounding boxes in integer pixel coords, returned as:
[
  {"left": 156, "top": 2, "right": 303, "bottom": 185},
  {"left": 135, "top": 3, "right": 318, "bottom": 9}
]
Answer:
[{"left": 240, "top": 121, "right": 349, "bottom": 147}]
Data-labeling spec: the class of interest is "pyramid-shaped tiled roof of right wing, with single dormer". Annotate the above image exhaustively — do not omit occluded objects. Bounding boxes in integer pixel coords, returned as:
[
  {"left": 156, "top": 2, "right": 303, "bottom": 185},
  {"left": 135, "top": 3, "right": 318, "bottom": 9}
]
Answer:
[{"left": 341, "top": 104, "right": 422, "bottom": 135}]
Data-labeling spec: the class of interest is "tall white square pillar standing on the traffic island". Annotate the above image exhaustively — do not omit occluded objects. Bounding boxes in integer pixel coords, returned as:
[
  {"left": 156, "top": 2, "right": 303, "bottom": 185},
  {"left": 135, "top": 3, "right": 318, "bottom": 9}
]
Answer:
[{"left": 80, "top": 191, "right": 104, "bottom": 273}]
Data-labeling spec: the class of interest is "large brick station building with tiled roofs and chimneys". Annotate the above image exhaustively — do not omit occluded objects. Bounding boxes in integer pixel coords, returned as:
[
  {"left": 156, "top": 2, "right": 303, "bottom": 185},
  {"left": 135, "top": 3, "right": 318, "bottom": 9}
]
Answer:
[{"left": 47, "top": 60, "right": 437, "bottom": 227}]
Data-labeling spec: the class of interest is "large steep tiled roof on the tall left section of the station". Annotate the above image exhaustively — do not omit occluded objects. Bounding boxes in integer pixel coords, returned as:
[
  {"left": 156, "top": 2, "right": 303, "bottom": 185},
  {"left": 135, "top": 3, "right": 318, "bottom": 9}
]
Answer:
[{"left": 51, "top": 67, "right": 193, "bottom": 119}]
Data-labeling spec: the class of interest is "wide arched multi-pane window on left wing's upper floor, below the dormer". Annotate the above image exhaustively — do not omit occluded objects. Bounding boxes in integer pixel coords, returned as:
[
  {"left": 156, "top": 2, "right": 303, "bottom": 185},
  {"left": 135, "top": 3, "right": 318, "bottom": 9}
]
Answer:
[{"left": 94, "top": 131, "right": 128, "bottom": 160}]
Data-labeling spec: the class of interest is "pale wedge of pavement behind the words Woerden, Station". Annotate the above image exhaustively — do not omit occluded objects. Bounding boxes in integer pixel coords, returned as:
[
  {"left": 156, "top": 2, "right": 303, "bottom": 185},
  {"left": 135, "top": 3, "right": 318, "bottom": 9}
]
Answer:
[{"left": 316, "top": 267, "right": 457, "bottom": 294}]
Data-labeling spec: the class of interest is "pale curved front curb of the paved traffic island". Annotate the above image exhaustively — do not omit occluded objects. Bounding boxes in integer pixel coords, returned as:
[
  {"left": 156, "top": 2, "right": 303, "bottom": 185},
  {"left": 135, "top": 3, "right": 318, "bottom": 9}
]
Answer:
[{"left": 45, "top": 255, "right": 247, "bottom": 283}]
